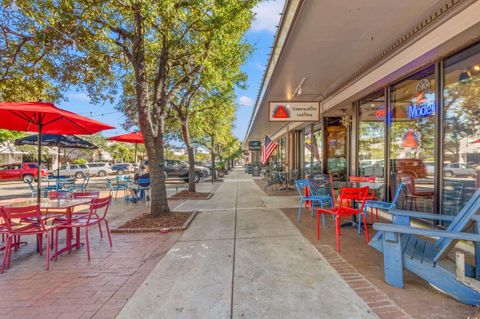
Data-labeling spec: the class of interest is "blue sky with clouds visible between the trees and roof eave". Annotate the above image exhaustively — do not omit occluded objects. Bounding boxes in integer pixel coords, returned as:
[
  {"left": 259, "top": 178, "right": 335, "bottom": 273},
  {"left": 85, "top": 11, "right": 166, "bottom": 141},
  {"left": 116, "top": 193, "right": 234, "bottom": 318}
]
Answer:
[{"left": 58, "top": 0, "right": 284, "bottom": 140}]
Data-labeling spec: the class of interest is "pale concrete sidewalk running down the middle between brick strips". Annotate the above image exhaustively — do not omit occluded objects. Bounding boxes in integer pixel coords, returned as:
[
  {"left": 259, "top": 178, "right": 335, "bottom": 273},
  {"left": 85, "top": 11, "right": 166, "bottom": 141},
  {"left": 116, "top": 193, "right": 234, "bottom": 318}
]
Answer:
[{"left": 118, "top": 169, "right": 376, "bottom": 319}]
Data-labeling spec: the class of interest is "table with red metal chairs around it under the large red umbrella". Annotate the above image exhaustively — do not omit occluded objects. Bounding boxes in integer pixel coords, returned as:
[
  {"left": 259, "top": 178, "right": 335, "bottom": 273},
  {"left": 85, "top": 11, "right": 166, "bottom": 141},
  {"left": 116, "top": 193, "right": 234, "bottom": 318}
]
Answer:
[{"left": 0, "top": 191, "right": 112, "bottom": 273}]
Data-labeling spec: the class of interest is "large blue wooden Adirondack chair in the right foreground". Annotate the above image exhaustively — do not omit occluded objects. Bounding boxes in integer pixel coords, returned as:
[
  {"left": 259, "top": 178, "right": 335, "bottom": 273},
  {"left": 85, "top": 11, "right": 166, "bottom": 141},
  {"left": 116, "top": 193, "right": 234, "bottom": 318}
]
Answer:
[{"left": 370, "top": 189, "right": 480, "bottom": 306}]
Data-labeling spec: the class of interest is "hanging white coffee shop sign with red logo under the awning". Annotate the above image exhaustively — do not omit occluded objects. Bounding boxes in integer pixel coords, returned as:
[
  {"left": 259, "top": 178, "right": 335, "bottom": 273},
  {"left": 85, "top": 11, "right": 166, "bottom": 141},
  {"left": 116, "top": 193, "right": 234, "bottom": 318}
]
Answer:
[{"left": 269, "top": 102, "right": 320, "bottom": 122}]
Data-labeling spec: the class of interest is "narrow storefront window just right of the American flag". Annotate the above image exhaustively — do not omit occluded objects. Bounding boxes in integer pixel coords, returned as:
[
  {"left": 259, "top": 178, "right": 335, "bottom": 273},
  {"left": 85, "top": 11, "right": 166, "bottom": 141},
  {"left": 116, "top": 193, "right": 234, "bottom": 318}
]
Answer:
[{"left": 305, "top": 124, "right": 322, "bottom": 175}]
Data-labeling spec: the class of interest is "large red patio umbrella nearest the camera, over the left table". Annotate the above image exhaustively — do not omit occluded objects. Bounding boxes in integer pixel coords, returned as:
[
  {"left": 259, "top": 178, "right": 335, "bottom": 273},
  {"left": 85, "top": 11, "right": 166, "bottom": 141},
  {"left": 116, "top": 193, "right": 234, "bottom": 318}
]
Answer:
[{"left": 0, "top": 102, "right": 114, "bottom": 201}]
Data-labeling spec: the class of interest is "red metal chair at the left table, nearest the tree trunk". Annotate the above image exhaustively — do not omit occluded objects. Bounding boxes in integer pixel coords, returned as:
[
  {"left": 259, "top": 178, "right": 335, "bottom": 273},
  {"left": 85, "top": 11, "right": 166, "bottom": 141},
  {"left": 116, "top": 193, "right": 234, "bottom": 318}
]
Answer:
[{"left": 55, "top": 195, "right": 112, "bottom": 260}]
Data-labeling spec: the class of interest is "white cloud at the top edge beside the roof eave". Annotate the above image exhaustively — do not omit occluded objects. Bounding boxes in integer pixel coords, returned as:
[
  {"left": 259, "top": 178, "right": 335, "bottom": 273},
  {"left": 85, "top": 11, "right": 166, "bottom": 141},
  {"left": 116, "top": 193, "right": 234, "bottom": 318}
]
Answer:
[{"left": 250, "top": 0, "right": 284, "bottom": 33}]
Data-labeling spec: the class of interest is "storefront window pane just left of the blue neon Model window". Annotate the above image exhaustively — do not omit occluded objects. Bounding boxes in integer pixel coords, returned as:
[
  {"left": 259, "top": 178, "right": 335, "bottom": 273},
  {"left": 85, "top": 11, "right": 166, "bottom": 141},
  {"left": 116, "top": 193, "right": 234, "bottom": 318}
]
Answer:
[{"left": 358, "top": 91, "right": 386, "bottom": 198}]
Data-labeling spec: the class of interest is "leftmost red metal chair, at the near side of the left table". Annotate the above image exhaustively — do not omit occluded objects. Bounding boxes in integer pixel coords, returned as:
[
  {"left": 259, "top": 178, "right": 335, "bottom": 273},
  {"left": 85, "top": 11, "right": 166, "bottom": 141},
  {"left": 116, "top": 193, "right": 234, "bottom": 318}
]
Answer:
[{"left": 0, "top": 205, "right": 62, "bottom": 273}]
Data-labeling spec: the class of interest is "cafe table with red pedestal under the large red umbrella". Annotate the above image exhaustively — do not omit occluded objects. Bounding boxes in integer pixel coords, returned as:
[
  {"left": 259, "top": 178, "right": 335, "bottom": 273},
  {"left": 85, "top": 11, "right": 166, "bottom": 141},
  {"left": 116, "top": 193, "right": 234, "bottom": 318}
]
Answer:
[{"left": 0, "top": 196, "right": 94, "bottom": 257}]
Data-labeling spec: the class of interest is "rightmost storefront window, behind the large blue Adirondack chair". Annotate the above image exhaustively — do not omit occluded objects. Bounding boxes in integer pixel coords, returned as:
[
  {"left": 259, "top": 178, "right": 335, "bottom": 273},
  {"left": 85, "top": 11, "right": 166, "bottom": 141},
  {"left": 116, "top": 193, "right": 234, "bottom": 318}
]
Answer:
[{"left": 442, "top": 44, "right": 480, "bottom": 215}]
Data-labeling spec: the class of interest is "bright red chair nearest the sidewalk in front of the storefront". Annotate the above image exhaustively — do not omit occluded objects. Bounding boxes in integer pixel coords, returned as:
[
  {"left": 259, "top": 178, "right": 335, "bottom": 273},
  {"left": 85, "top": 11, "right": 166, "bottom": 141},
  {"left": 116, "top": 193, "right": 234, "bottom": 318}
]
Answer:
[{"left": 317, "top": 186, "right": 370, "bottom": 252}]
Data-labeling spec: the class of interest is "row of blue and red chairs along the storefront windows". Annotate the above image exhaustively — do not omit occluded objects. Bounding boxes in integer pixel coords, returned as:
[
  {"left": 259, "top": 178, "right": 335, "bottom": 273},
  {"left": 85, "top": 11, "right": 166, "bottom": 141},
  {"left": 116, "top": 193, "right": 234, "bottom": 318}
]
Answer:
[{"left": 288, "top": 174, "right": 480, "bottom": 305}]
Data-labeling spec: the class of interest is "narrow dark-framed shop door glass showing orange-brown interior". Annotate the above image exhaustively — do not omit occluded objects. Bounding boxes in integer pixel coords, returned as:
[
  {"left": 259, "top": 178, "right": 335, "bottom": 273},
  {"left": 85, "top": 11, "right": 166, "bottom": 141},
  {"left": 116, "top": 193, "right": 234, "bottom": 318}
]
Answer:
[{"left": 326, "top": 117, "right": 348, "bottom": 181}]
